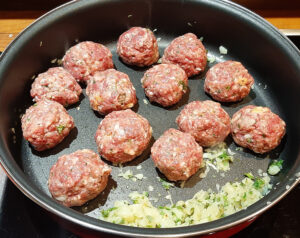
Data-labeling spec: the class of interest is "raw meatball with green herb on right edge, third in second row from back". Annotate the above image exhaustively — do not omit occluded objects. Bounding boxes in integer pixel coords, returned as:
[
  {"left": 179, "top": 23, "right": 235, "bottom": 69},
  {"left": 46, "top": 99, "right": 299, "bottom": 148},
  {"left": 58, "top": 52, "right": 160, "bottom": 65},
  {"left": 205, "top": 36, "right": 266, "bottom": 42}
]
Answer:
[{"left": 141, "top": 64, "right": 188, "bottom": 107}]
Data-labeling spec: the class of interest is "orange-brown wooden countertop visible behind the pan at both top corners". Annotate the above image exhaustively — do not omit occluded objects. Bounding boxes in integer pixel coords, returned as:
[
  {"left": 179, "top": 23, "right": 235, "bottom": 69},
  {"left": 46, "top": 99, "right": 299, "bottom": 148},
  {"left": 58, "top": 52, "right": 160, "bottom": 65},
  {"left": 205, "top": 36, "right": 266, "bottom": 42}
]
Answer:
[{"left": 0, "top": 9, "right": 300, "bottom": 51}]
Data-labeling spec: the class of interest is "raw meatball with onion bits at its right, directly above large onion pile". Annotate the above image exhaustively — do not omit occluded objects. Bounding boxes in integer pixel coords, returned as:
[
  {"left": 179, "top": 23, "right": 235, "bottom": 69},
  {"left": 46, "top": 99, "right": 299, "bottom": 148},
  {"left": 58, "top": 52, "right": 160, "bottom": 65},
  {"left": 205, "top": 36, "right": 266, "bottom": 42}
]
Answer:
[{"left": 151, "top": 128, "right": 203, "bottom": 181}]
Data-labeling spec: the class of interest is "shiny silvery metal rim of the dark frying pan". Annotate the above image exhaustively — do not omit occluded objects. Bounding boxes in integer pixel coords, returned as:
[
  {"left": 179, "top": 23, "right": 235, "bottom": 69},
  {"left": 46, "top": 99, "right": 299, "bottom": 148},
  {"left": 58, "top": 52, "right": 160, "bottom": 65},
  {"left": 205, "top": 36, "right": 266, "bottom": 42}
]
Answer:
[{"left": 0, "top": 0, "right": 300, "bottom": 237}]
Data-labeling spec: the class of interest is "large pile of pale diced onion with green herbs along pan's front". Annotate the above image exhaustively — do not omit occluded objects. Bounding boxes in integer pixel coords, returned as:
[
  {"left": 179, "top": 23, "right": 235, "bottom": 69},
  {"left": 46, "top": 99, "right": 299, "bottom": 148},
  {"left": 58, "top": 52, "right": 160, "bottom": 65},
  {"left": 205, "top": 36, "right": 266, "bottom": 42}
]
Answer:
[{"left": 101, "top": 176, "right": 272, "bottom": 228}]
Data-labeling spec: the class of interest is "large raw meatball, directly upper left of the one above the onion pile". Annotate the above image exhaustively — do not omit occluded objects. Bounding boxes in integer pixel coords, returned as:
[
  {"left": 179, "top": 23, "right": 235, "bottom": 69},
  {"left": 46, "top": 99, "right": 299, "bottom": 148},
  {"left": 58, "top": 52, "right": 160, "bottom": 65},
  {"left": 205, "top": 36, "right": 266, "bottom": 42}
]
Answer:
[{"left": 95, "top": 109, "right": 152, "bottom": 164}]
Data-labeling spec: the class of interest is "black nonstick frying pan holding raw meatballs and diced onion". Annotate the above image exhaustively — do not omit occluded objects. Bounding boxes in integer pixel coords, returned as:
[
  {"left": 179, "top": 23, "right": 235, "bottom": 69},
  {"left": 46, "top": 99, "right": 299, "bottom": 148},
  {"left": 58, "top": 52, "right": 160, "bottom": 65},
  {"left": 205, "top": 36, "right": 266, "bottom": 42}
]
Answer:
[{"left": 0, "top": 0, "right": 300, "bottom": 237}]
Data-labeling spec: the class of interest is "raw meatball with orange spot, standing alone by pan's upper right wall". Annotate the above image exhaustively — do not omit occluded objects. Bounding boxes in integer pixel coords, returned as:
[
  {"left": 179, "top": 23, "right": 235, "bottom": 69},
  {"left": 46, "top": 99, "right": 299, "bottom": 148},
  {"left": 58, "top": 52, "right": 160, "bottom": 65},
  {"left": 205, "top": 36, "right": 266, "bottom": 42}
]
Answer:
[{"left": 204, "top": 61, "right": 254, "bottom": 102}]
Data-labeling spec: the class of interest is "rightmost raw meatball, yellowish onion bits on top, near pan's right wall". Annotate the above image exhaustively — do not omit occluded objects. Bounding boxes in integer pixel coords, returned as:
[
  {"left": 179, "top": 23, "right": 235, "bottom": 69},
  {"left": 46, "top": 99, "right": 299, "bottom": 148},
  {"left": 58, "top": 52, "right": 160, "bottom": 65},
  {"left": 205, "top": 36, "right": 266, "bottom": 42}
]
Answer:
[{"left": 231, "top": 105, "right": 285, "bottom": 154}]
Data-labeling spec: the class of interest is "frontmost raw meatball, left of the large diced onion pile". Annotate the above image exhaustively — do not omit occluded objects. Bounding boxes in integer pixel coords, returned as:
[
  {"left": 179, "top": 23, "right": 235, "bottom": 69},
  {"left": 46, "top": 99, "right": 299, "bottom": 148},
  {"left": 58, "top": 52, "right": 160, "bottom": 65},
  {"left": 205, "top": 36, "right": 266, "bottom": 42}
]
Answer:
[{"left": 48, "top": 149, "right": 111, "bottom": 207}]
